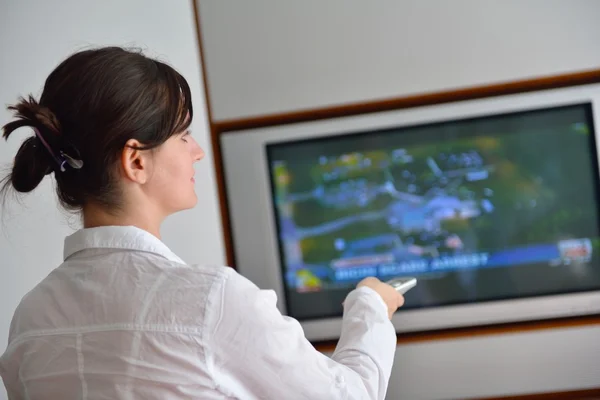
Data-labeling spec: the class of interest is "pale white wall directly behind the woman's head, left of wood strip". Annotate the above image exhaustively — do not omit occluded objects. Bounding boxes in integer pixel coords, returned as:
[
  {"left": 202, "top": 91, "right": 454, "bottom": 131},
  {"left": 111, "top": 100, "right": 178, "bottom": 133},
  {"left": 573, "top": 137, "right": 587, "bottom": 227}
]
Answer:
[{"left": 0, "top": 0, "right": 224, "bottom": 399}]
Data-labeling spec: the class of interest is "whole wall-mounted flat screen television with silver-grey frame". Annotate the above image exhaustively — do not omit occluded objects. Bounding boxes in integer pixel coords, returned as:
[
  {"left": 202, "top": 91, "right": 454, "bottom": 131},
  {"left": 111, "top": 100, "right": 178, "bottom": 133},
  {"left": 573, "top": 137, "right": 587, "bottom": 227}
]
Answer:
[{"left": 222, "top": 86, "right": 600, "bottom": 340}]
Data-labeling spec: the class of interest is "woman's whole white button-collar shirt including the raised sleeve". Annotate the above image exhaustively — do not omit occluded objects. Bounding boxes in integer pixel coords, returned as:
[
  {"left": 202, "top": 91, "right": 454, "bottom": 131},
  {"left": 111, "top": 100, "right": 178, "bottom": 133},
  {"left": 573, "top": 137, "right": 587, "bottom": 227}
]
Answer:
[{"left": 0, "top": 227, "right": 396, "bottom": 400}]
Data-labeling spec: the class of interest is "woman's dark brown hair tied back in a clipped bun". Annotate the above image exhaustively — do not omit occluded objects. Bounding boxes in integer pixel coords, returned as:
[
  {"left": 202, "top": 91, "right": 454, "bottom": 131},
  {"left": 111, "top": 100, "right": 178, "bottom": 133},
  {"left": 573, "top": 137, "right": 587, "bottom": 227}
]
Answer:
[{"left": 2, "top": 47, "right": 193, "bottom": 210}]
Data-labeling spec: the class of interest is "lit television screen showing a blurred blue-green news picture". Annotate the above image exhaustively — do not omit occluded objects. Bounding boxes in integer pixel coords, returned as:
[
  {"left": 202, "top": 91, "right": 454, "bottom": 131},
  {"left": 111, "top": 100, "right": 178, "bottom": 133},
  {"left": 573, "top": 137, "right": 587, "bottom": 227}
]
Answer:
[{"left": 266, "top": 103, "right": 600, "bottom": 320}]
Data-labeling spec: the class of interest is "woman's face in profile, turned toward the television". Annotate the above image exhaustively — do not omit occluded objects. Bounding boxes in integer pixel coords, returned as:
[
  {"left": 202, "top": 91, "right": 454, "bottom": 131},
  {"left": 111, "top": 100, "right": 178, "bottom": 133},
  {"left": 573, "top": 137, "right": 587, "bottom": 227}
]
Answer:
[{"left": 146, "top": 131, "right": 204, "bottom": 215}]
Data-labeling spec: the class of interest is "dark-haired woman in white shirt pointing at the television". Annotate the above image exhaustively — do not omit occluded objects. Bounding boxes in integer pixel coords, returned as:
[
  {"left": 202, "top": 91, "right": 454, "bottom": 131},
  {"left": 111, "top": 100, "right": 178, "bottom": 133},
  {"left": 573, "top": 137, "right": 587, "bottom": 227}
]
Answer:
[{"left": 0, "top": 47, "right": 403, "bottom": 400}]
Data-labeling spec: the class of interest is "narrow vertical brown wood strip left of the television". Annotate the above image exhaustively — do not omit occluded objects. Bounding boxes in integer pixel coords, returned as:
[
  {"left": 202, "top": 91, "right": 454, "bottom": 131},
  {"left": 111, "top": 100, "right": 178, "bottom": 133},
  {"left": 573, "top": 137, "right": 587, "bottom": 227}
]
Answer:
[{"left": 190, "top": 0, "right": 235, "bottom": 269}]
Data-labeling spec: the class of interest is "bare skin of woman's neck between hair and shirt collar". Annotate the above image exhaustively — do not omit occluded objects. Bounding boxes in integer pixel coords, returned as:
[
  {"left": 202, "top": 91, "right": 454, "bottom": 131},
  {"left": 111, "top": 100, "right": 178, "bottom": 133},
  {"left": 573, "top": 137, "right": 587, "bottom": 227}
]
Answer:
[{"left": 83, "top": 204, "right": 163, "bottom": 239}]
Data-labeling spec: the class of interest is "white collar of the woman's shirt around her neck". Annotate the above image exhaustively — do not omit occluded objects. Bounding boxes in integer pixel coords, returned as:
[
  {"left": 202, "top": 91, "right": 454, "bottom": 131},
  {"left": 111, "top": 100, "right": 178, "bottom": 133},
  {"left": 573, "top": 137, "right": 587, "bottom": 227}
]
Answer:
[{"left": 63, "top": 226, "right": 185, "bottom": 264}]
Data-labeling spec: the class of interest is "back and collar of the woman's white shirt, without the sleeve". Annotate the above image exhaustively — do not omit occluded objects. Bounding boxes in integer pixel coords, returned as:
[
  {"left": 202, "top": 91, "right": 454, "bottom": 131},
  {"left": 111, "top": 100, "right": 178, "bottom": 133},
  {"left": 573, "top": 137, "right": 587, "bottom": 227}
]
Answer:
[{"left": 0, "top": 227, "right": 227, "bottom": 399}]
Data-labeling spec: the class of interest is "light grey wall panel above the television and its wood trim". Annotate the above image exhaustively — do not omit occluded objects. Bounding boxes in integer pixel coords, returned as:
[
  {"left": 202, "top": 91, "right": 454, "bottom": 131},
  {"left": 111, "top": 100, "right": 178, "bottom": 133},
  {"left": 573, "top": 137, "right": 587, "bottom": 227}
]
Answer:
[{"left": 200, "top": 0, "right": 600, "bottom": 120}]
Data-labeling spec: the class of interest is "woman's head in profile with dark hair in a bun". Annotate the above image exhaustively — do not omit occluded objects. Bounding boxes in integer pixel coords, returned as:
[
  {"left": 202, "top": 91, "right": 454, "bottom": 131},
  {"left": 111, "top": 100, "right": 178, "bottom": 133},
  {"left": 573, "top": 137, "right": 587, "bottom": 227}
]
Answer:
[{"left": 3, "top": 47, "right": 203, "bottom": 227}]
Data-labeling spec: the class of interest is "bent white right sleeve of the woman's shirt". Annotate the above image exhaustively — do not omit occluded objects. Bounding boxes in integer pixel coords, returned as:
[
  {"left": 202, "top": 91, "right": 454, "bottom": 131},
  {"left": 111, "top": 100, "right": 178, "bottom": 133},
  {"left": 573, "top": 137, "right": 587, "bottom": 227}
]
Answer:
[{"left": 208, "top": 271, "right": 396, "bottom": 400}]
